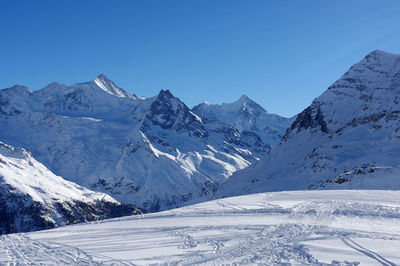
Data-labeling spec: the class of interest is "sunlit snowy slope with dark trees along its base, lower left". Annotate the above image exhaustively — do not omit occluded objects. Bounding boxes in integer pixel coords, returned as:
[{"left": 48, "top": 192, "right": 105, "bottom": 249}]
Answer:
[{"left": 0, "top": 142, "right": 141, "bottom": 234}]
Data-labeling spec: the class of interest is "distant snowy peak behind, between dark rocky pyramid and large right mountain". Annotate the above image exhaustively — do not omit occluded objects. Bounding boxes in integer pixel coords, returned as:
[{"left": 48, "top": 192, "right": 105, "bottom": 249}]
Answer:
[{"left": 192, "top": 95, "right": 294, "bottom": 147}]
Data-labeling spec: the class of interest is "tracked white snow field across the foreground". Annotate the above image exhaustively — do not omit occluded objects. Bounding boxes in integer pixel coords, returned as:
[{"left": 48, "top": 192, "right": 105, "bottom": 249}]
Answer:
[{"left": 0, "top": 190, "right": 400, "bottom": 265}]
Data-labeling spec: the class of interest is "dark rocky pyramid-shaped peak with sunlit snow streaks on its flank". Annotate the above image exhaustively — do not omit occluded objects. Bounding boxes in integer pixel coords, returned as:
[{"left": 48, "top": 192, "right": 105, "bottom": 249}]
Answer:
[{"left": 112, "top": 90, "right": 269, "bottom": 211}]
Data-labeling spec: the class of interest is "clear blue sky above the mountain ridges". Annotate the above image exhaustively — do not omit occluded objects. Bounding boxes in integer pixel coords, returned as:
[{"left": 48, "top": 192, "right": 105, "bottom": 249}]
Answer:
[{"left": 0, "top": 0, "right": 400, "bottom": 116}]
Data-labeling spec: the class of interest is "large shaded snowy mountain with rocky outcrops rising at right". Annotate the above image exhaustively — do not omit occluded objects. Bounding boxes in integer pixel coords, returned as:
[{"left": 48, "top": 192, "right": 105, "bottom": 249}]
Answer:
[{"left": 218, "top": 50, "right": 400, "bottom": 196}]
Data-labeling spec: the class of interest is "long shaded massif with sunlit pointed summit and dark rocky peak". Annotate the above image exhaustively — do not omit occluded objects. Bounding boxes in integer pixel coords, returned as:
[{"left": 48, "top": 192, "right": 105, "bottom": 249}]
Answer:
[{"left": 0, "top": 75, "right": 269, "bottom": 211}]
